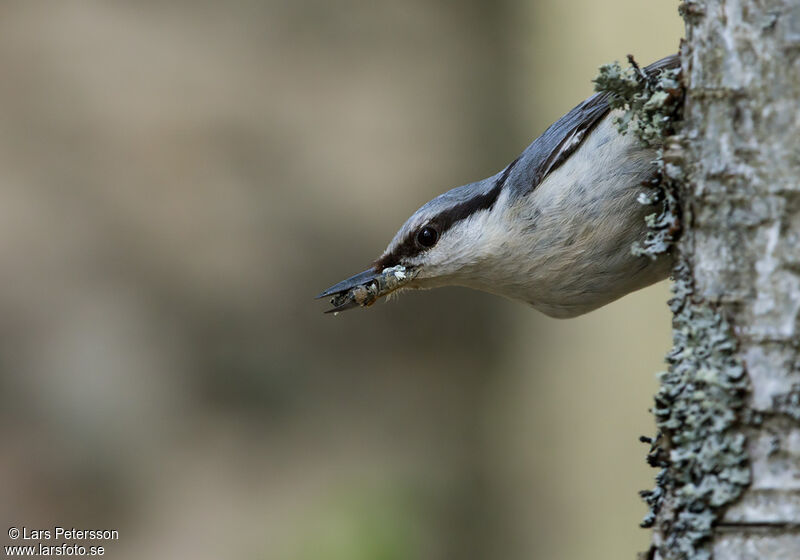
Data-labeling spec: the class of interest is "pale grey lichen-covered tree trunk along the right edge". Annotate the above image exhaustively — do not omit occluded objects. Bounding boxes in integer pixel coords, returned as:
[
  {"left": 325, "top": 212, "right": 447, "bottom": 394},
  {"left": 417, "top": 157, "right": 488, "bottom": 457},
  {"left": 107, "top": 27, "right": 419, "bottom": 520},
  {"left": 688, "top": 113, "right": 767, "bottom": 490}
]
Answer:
[{"left": 648, "top": 0, "right": 800, "bottom": 560}]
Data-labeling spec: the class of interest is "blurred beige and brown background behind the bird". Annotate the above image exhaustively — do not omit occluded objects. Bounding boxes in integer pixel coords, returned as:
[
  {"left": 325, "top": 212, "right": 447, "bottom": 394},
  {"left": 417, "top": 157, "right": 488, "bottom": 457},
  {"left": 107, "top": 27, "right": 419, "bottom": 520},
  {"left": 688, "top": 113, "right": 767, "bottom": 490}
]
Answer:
[{"left": 0, "top": 0, "right": 682, "bottom": 560}]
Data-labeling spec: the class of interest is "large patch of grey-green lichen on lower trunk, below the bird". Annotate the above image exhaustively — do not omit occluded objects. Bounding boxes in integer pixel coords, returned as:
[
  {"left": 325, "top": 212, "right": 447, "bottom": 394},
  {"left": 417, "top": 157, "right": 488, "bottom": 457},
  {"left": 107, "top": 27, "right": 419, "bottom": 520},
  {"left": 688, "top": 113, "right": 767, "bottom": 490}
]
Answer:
[{"left": 642, "top": 262, "right": 750, "bottom": 560}]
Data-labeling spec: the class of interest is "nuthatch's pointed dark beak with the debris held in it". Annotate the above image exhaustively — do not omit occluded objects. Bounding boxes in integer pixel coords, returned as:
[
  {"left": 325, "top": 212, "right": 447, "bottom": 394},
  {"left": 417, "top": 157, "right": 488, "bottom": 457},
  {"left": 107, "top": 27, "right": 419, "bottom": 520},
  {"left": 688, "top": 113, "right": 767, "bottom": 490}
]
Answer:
[{"left": 317, "top": 266, "right": 416, "bottom": 313}]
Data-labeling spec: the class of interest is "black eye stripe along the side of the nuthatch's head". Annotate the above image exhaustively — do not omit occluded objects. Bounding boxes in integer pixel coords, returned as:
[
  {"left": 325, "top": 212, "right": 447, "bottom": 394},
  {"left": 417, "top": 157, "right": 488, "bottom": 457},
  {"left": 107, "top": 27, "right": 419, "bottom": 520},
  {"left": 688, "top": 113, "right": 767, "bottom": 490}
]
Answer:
[{"left": 374, "top": 154, "right": 519, "bottom": 270}]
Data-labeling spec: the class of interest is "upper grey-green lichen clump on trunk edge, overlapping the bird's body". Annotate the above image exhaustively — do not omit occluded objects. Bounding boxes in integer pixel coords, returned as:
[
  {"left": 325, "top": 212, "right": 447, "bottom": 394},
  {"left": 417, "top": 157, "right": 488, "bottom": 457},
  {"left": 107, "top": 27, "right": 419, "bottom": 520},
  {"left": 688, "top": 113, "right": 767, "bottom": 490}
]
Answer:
[{"left": 594, "top": 55, "right": 683, "bottom": 259}]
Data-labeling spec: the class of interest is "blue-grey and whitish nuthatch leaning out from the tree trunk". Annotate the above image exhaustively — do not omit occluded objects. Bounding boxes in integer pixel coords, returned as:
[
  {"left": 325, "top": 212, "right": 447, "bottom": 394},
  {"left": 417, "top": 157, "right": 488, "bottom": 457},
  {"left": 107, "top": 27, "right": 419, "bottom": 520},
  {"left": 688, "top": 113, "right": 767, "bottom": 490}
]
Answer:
[{"left": 319, "top": 56, "right": 679, "bottom": 317}]
